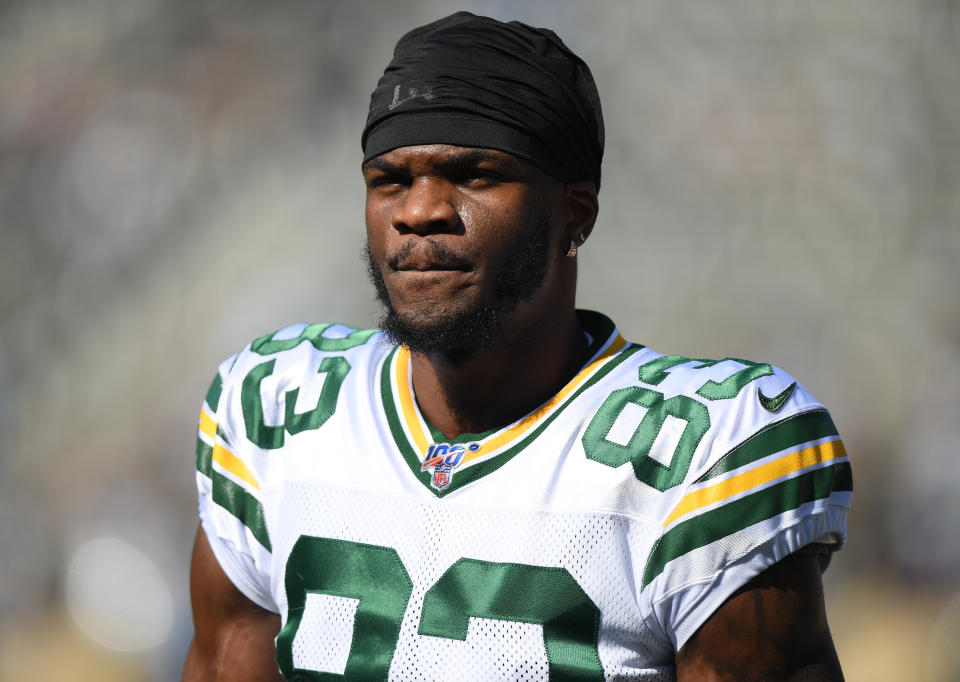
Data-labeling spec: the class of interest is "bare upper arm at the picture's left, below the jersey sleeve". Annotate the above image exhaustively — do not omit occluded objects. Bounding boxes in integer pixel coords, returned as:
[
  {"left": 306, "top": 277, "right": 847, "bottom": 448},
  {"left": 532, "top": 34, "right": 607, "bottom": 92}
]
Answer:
[{"left": 182, "top": 528, "right": 283, "bottom": 682}]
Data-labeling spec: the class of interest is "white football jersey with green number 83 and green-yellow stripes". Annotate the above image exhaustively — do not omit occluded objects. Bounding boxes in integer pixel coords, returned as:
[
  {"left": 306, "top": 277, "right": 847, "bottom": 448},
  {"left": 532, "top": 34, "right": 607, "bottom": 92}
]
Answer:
[{"left": 197, "top": 311, "right": 852, "bottom": 682}]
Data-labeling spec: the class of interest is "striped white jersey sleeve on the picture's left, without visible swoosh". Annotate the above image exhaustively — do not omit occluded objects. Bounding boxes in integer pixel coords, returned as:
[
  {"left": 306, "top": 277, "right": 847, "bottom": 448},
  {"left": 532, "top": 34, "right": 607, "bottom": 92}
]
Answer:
[{"left": 196, "top": 356, "right": 279, "bottom": 613}]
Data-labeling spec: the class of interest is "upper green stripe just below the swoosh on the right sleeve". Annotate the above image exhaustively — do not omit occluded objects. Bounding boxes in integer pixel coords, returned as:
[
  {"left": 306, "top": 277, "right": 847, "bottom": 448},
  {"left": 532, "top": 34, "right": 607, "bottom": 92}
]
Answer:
[{"left": 697, "top": 410, "right": 837, "bottom": 483}]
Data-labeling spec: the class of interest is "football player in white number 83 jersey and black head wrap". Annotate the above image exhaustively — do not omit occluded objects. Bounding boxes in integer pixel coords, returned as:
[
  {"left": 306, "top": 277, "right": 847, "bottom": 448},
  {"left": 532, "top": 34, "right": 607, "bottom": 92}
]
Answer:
[{"left": 183, "top": 12, "right": 852, "bottom": 682}]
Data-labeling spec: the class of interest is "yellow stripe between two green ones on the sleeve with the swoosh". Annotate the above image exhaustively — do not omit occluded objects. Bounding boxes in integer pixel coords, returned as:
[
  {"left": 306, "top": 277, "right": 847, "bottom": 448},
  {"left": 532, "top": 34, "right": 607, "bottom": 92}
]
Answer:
[{"left": 663, "top": 440, "right": 847, "bottom": 527}]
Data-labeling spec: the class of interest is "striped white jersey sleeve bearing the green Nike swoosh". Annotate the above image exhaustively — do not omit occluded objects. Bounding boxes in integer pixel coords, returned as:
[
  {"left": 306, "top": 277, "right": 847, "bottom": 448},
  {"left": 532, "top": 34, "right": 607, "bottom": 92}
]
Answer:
[{"left": 641, "top": 365, "right": 852, "bottom": 651}]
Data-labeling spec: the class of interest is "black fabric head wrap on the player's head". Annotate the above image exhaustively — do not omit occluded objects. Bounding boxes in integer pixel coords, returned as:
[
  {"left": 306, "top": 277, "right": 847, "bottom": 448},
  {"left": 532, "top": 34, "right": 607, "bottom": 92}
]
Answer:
[{"left": 361, "top": 12, "right": 604, "bottom": 189}]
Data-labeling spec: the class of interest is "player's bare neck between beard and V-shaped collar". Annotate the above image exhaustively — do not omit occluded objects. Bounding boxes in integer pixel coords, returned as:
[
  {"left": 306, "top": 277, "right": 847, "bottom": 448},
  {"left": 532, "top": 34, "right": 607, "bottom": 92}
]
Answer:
[{"left": 412, "top": 308, "right": 588, "bottom": 438}]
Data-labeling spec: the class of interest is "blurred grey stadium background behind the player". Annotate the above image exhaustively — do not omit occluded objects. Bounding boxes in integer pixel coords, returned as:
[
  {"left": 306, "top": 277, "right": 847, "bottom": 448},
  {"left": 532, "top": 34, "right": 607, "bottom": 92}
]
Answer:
[{"left": 0, "top": 0, "right": 960, "bottom": 682}]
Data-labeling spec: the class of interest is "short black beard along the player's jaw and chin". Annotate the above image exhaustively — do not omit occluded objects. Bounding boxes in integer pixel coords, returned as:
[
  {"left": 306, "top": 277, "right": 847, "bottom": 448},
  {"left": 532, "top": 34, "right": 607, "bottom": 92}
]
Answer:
[{"left": 364, "top": 211, "right": 553, "bottom": 360}]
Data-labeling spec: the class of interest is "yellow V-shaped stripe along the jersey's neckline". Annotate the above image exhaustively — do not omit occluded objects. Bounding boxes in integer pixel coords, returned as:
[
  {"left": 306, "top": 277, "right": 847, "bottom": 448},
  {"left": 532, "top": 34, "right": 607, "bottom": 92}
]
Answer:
[{"left": 395, "top": 334, "right": 627, "bottom": 462}]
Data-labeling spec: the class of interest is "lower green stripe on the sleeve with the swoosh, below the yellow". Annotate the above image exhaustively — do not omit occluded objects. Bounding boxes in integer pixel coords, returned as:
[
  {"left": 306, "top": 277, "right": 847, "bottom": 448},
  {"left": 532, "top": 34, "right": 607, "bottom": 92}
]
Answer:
[{"left": 643, "top": 462, "right": 853, "bottom": 587}]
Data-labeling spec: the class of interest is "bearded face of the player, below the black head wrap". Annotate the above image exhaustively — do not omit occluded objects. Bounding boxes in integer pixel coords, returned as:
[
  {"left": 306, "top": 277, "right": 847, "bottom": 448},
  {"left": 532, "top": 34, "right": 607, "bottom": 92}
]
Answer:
[{"left": 363, "top": 145, "right": 564, "bottom": 352}]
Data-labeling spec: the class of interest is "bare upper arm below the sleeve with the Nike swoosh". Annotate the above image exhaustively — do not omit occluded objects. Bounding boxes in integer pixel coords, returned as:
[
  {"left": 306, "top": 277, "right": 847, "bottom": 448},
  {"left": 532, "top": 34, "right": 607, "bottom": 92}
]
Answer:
[{"left": 676, "top": 553, "right": 843, "bottom": 682}]
